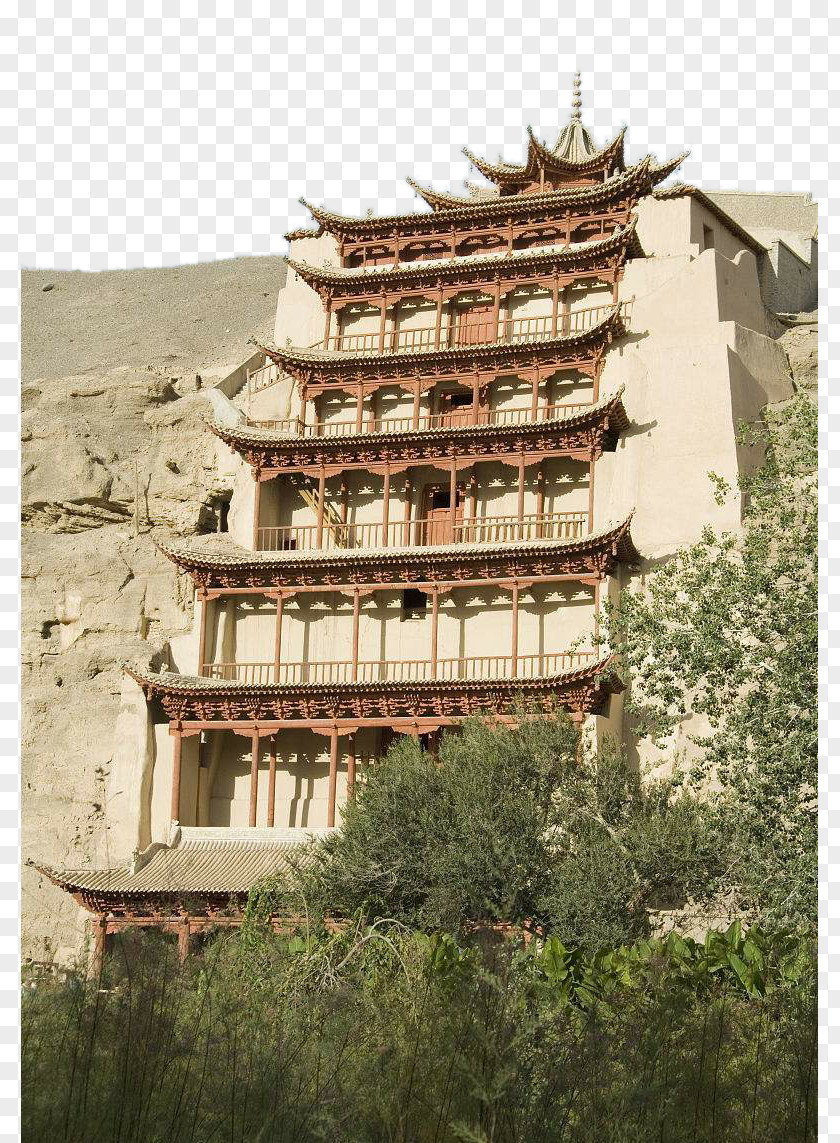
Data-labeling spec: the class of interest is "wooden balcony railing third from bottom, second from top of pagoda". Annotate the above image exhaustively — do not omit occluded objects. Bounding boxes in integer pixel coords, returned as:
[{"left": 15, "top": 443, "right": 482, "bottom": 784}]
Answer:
[{"left": 248, "top": 402, "right": 592, "bottom": 438}]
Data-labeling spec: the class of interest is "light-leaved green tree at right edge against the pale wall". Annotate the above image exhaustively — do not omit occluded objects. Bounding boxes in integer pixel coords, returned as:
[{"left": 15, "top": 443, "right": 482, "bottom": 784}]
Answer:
[{"left": 611, "top": 394, "right": 818, "bottom": 924}]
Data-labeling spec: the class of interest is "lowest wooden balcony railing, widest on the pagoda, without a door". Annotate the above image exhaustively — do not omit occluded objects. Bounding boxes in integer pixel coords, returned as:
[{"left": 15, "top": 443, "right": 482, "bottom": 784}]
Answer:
[{"left": 200, "top": 650, "right": 595, "bottom": 686}]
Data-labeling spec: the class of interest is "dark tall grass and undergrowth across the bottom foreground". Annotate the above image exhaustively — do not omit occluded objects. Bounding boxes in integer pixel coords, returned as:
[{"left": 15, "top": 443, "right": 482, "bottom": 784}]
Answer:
[{"left": 23, "top": 924, "right": 816, "bottom": 1143}]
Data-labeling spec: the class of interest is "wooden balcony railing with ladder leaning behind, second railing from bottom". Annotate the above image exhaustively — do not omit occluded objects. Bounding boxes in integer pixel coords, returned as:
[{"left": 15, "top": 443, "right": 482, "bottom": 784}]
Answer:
[{"left": 256, "top": 510, "right": 589, "bottom": 552}]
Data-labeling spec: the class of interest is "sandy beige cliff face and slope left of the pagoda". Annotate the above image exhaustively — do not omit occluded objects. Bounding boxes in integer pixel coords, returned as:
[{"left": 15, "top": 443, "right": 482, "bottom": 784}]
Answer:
[{"left": 22, "top": 258, "right": 285, "bottom": 960}]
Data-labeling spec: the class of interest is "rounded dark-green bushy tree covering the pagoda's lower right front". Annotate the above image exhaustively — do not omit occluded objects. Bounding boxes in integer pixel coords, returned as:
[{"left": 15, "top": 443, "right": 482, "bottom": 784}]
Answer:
[{"left": 267, "top": 711, "right": 720, "bottom": 950}]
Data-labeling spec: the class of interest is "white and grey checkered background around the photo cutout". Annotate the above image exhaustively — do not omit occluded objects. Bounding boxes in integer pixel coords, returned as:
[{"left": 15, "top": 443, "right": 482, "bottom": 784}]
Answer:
[{"left": 0, "top": 0, "right": 840, "bottom": 1138}]
